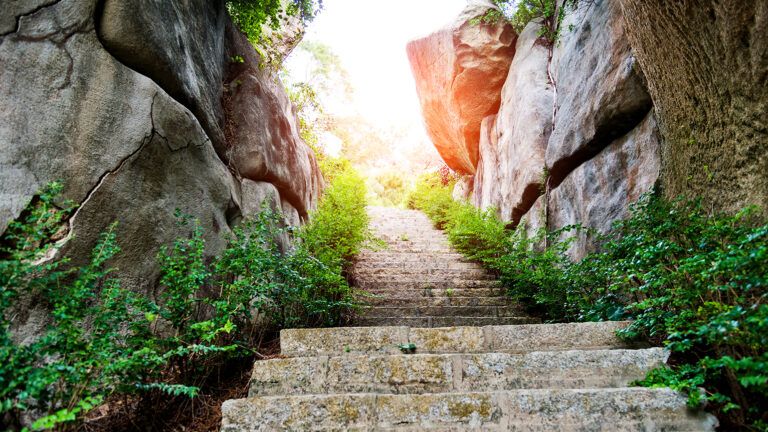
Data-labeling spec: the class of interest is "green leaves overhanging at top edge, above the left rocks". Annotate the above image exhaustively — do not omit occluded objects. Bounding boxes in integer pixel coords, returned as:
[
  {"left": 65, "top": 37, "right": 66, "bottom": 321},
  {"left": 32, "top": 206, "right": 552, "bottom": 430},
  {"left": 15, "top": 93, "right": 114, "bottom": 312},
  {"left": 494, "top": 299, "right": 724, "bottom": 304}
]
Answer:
[{"left": 227, "top": 0, "right": 323, "bottom": 44}]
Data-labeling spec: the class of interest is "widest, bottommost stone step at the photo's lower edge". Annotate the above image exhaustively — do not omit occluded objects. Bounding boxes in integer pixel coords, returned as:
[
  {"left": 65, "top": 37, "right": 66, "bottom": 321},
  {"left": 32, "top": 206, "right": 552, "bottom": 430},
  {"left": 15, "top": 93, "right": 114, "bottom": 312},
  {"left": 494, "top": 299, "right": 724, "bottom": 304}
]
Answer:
[{"left": 221, "top": 388, "right": 717, "bottom": 432}]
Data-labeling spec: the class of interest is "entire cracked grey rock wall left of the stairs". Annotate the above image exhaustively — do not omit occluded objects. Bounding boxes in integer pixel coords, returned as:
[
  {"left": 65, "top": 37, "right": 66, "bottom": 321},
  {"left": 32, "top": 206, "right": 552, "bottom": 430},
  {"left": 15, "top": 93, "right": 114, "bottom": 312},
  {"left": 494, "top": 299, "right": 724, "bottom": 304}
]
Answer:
[{"left": 0, "top": 0, "right": 322, "bottom": 293}]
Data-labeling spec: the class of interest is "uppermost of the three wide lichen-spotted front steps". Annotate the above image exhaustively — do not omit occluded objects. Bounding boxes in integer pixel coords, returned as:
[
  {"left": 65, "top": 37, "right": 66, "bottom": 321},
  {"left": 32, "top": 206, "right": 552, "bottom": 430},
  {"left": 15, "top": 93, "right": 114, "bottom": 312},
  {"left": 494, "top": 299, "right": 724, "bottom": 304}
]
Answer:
[{"left": 280, "top": 321, "right": 629, "bottom": 357}]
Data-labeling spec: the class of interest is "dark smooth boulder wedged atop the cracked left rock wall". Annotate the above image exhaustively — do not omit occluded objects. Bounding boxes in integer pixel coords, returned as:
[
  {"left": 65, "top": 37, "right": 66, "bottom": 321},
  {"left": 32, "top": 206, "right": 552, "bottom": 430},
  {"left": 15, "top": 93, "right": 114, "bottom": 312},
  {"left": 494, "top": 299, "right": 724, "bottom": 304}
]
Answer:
[{"left": 97, "top": 0, "right": 229, "bottom": 154}]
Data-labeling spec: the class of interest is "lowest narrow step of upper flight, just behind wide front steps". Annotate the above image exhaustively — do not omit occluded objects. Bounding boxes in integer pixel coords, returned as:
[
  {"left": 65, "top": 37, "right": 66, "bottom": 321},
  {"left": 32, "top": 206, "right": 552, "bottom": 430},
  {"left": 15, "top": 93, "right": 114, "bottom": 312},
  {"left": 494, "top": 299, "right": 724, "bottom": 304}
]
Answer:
[{"left": 352, "top": 316, "right": 541, "bottom": 327}]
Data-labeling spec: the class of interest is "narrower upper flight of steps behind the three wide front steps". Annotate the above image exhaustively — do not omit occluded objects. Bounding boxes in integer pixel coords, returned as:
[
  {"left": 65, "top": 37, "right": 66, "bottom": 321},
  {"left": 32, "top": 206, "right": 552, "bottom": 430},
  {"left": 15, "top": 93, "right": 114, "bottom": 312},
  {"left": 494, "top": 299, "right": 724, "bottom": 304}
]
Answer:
[{"left": 353, "top": 207, "right": 538, "bottom": 327}]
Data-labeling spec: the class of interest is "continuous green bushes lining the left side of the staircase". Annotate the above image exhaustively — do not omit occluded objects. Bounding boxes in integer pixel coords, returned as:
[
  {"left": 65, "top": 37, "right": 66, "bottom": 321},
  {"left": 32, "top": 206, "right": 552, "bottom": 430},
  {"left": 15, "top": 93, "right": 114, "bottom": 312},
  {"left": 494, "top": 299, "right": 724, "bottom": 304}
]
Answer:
[{"left": 0, "top": 175, "right": 368, "bottom": 430}]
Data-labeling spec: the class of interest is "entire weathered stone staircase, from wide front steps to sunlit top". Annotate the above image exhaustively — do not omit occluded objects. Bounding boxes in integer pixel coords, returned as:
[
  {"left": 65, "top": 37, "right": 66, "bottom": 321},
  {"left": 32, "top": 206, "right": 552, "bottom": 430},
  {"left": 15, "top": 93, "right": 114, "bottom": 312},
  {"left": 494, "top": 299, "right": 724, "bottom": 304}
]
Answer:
[{"left": 222, "top": 209, "right": 717, "bottom": 432}]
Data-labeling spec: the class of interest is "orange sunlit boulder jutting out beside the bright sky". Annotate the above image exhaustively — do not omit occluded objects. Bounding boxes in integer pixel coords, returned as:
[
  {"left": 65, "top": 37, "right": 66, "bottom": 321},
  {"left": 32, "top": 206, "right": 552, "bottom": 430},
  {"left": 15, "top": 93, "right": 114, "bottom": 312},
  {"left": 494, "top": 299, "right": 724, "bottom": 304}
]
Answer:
[{"left": 407, "top": 0, "right": 516, "bottom": 174}]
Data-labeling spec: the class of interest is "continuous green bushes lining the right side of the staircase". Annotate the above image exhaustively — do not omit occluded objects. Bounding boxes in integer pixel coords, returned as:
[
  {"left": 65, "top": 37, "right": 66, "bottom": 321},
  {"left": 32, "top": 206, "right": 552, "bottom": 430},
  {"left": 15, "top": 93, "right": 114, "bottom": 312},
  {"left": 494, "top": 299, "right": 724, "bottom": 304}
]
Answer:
[{"left": 410, "top": 176, "right": 768, "bottom": 430}]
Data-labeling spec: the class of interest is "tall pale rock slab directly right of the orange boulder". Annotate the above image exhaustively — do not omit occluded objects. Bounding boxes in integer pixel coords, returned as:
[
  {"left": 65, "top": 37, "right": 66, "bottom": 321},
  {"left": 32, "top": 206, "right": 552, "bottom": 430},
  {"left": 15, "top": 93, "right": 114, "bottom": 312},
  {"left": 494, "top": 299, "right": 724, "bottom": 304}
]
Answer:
[{"left": 475, "top": 23, "right": 553, "bottom": 223}]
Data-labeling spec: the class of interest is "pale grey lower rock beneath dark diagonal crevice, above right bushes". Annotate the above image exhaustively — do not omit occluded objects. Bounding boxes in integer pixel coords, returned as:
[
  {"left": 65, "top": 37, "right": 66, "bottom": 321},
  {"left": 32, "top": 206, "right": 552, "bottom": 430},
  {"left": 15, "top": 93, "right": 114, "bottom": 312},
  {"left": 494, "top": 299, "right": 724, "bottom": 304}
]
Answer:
[{"left": 548, "top": 113, "right": 660, "bottom": 259}]
